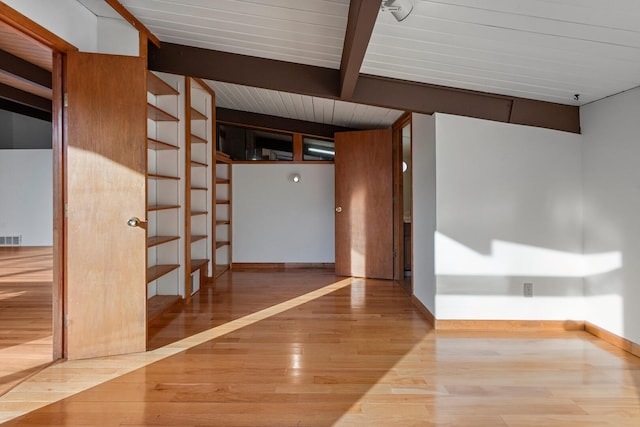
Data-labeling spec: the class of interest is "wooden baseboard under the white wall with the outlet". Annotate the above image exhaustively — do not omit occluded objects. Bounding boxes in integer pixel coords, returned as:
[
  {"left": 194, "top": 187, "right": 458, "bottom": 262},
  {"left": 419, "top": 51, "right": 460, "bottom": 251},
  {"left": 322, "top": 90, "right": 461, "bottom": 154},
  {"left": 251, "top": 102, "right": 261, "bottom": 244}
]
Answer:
[{"left": 435, "top": 320, "right": 584, "bottom": 331}]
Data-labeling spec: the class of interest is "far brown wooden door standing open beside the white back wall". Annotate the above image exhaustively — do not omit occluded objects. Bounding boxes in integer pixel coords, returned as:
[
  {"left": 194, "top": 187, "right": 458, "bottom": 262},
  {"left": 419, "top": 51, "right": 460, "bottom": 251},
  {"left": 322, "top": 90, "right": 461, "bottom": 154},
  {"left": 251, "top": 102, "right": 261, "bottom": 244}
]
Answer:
[{"left": 335, "top": 129, "right": 393, "bottom": 279}]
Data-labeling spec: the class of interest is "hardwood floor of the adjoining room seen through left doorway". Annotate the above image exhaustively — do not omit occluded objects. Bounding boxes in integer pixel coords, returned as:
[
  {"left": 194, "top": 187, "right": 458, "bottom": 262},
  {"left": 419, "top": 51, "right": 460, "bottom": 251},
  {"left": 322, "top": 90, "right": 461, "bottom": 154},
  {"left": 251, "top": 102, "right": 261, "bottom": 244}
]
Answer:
[{"left": 0, "top": 247, "right": 53, "bottom": 396}]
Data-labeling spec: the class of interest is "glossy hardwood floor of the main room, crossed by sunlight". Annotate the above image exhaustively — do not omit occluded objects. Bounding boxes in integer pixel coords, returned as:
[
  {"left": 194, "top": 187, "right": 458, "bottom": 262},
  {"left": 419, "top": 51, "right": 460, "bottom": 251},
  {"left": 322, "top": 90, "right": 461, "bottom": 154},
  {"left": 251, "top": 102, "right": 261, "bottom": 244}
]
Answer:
[{"left": 0, "top": 272, "right": 640, "bottom": 427}]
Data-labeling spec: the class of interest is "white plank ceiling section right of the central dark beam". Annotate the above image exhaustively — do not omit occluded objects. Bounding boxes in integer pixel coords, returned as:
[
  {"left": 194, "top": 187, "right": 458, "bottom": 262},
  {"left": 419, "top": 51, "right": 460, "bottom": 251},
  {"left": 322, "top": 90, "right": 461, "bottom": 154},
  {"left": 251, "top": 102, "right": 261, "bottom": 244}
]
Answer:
[{"left": 361, "top": 0, "right": 640, "bottom": 105}]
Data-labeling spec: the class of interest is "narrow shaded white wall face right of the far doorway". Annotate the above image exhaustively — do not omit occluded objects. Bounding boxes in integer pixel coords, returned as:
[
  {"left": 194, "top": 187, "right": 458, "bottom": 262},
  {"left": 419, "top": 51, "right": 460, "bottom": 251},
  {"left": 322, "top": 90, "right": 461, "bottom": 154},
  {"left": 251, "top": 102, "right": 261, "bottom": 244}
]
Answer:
[{"left": 411, "top": 114, "right": 436, "bottom": 315}]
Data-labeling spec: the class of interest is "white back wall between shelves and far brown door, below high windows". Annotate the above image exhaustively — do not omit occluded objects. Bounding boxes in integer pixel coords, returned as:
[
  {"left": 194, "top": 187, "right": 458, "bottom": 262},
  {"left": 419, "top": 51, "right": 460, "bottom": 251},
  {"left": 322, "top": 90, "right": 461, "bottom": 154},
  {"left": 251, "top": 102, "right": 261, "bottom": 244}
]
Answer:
[{"left": 232, "top": 164, "right": 335, "bottom": 263}]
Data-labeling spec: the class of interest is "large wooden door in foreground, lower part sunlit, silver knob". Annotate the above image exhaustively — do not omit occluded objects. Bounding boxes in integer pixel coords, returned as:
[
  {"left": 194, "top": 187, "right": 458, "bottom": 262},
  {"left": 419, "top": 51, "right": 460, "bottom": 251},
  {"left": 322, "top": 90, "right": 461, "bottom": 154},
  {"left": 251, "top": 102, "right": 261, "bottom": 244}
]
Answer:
[{"left": 65, "top": 53, "right": 146, "bottom": 359}]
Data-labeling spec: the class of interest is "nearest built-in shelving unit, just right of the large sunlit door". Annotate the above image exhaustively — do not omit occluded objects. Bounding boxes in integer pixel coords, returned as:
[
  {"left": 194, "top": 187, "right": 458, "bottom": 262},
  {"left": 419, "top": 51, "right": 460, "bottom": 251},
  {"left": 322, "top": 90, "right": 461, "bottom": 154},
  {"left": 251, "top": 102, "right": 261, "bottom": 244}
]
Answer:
[{"left": 147, "top": 72, "right": 184, "bottom": 332}]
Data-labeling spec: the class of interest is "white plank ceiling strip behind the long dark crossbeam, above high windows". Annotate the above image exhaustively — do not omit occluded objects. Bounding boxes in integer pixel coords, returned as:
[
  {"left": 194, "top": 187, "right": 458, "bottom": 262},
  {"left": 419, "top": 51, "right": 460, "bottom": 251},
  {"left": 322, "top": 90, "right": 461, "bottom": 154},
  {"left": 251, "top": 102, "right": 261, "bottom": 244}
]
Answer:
[{"left": 206, "top": 80, "right": 404, "bottom": 129}]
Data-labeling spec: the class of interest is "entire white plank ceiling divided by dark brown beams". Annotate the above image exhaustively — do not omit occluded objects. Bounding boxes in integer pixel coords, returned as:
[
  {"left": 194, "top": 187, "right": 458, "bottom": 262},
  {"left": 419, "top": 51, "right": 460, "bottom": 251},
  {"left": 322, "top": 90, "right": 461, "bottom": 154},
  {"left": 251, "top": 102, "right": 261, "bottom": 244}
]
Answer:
[{"left": 119, "top": 0, "right": 640, "bottom": 124}]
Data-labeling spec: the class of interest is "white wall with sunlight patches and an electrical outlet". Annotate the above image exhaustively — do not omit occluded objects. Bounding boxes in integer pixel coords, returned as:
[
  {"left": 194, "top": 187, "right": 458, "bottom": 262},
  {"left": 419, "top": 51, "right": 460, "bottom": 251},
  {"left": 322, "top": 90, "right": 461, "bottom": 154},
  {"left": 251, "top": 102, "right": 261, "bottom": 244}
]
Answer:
[{"left": 436, "top": 114, "right": 585, "bottom": 320}]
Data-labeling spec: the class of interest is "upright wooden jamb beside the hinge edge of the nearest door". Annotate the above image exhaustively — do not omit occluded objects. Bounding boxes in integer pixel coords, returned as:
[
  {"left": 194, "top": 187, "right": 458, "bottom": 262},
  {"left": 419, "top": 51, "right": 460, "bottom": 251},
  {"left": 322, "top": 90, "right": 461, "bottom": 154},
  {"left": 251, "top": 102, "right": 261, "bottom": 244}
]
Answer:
[{"left": 51, "top": 52, "right": 66, "bottom": 360}]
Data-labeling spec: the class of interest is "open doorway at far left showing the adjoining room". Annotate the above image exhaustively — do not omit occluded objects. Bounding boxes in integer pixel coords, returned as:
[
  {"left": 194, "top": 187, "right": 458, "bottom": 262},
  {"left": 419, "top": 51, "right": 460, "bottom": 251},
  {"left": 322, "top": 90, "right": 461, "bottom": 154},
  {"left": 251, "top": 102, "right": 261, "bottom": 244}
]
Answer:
[{"left": 0, "top": 6, "right": 63, "bottom": 394}]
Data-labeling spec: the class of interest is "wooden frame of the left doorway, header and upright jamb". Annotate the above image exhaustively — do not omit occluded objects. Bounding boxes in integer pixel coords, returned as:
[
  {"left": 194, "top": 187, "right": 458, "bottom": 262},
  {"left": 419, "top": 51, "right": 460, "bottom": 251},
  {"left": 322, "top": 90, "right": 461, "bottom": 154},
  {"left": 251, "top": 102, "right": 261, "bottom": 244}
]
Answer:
[{"left": 0, "top": 3, "right": 78, "bottom": 360}]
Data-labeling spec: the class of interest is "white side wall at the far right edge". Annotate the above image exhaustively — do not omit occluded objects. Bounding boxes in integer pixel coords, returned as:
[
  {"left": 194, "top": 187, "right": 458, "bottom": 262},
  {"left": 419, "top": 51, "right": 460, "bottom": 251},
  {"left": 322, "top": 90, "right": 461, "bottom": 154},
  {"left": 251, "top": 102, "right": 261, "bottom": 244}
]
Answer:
[{"left": 580, "top": 89, "right": 640, "bottom": 343}]
